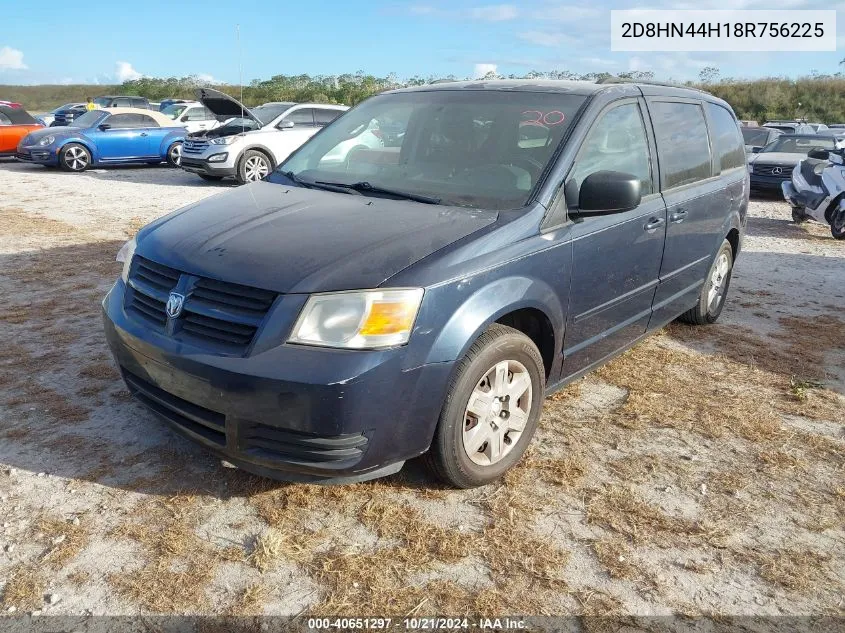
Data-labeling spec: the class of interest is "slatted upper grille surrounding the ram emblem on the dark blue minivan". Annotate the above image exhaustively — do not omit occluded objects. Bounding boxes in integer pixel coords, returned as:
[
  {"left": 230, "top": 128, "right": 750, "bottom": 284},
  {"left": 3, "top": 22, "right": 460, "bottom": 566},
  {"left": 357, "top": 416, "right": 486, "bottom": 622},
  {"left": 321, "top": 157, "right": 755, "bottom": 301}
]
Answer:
[{"left": 126, "top": 256, "right": 277, "bottom": 355}]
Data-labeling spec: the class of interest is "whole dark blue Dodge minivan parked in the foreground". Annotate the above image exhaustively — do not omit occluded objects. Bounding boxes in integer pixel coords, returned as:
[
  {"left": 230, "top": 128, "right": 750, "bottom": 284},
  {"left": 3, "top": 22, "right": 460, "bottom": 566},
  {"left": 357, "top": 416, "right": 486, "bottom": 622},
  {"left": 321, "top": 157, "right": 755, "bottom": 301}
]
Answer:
[{"left": 103, "top": 80, "right": 749, "bottom": 487}]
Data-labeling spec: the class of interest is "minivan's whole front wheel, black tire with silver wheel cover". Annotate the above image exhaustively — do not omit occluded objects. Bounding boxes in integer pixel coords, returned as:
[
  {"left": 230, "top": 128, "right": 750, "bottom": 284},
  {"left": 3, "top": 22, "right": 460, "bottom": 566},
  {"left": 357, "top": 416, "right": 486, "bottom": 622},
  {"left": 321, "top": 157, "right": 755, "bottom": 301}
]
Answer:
[{"left": 425, "top": 324, "right": 546, "bottom": 488}]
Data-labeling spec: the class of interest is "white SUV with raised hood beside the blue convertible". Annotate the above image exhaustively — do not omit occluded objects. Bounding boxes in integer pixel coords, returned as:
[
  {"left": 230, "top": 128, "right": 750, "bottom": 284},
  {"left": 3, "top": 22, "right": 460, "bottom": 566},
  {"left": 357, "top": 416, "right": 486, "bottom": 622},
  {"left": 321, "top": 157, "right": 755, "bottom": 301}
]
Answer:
[{"left": 182, "top": 88, "right": 349, "bottom": 183}]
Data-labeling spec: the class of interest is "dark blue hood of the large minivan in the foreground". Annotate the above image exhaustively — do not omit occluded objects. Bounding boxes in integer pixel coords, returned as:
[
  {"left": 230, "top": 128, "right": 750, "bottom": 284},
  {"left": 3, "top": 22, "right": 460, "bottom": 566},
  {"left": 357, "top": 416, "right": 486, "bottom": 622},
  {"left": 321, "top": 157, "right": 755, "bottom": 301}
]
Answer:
[{"left": 137, "top": 181, "right": 498, "bottom": 293}]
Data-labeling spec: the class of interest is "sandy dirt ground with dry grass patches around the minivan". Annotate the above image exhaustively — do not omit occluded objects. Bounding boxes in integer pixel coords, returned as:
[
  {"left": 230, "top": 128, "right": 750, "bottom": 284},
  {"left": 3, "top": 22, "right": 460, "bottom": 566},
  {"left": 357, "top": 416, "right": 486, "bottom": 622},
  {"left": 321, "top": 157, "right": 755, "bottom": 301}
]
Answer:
[{"left": 0, "top": 162, "right": 845, "bottom": 616}]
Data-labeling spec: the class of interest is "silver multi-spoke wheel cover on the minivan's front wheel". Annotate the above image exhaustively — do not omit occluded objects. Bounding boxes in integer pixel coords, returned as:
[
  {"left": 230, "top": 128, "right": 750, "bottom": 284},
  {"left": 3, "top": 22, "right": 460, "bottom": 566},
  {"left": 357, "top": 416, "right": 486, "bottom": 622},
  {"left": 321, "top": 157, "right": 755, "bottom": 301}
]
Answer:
[{"left": 463, "top": 360, "right": 533, "bottom": 466}]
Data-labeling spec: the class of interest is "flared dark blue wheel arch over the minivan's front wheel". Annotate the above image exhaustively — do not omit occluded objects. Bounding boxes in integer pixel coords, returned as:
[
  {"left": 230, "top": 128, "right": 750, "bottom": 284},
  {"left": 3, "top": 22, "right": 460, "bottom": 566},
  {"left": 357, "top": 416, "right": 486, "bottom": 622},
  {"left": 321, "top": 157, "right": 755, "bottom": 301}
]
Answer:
[{"left": 425, "top": 276, "right": 565, "bottom": 368}]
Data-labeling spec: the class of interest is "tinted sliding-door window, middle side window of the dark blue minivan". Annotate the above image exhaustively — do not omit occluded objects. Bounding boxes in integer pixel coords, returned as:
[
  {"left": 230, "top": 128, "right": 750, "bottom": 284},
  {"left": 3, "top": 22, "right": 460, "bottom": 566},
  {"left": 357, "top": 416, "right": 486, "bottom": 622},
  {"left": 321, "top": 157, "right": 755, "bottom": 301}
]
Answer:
[{"left": 649, "top": 101, "right": 711, "bottom": 189}]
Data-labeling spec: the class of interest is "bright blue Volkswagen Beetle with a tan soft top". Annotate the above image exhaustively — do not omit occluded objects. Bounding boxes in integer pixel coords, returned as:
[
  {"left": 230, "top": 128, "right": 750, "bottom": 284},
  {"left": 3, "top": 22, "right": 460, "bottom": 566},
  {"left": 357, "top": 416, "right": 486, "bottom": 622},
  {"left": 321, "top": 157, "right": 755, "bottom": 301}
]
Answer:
[{"left": 15, "top": 108, "right": 186, "bottom": 171}]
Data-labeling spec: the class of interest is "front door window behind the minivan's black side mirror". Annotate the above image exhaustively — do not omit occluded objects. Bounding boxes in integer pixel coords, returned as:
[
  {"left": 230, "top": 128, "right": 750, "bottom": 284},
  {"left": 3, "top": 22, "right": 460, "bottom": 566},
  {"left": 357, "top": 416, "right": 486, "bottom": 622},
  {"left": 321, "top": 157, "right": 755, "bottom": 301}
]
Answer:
[{"left": 570, "top": 103, "right": 654, "bottom": 196}]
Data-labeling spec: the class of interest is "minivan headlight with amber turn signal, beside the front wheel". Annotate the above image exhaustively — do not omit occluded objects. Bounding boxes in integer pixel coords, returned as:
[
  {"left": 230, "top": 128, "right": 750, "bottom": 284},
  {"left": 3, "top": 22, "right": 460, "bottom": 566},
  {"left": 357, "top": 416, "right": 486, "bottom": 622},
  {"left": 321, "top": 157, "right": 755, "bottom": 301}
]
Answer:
[{"left": 288, "top": 288, "right": 423, "bottom": 349}]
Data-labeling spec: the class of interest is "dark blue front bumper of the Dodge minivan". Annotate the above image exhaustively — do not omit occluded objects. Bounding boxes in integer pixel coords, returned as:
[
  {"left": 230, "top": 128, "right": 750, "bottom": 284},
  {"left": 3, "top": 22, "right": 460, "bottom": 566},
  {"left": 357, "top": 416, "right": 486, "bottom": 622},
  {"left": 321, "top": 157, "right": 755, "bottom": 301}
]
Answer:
[{"left": 103, "top": 281, "right": 453, "bottom": 483}]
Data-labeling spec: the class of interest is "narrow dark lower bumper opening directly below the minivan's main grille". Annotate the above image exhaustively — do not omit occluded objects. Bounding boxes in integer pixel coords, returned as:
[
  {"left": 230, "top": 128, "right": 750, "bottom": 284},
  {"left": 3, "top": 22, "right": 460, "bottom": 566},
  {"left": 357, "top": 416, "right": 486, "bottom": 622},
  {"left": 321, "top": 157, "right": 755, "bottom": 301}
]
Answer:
[{"left": 123, "top": 370, "right": 226, "bottom": 446}]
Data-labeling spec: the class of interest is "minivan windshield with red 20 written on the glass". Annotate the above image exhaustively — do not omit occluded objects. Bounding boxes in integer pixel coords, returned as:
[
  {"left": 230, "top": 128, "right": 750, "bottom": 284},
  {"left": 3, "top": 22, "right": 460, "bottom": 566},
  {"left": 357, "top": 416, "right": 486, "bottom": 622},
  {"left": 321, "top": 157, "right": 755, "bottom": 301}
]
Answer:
[{"left": 269, "top": 90, "right": 586, "bottom": 210}]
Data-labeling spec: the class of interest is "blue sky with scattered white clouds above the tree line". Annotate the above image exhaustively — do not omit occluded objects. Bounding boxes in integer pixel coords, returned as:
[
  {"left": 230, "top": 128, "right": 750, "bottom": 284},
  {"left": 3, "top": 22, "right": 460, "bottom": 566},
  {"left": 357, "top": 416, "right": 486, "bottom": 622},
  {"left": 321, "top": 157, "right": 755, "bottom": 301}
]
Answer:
[{"left": 0, "top": 0, "right": 845, "bottom": 84}]
